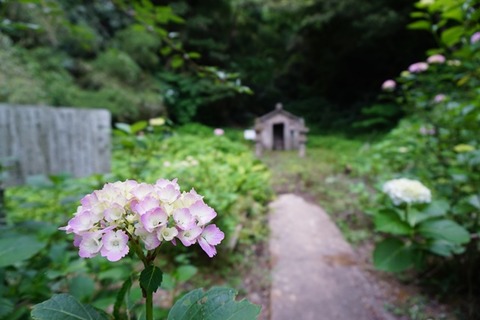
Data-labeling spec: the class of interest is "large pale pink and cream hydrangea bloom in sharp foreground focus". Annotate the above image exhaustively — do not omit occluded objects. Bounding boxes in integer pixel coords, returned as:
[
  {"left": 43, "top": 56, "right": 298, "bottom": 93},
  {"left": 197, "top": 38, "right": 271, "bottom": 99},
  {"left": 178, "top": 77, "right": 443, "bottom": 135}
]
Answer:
[{"left": 60, "top": 179, "right": 225, "bottom": 261}]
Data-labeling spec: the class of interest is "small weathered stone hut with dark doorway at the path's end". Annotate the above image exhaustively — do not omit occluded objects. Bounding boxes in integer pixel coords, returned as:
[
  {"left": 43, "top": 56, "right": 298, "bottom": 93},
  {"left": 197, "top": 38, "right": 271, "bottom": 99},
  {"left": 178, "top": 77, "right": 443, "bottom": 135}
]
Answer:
[{"left": 255, "top": 103, "right": 308, "bottom": 157}]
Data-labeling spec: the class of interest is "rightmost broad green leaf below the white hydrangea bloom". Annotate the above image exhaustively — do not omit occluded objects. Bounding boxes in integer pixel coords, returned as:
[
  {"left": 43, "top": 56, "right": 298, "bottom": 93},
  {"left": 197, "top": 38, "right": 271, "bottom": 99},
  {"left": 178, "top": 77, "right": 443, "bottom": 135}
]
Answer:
[{"left": 418, "top": 219, "right": 470, "bottom": 244}]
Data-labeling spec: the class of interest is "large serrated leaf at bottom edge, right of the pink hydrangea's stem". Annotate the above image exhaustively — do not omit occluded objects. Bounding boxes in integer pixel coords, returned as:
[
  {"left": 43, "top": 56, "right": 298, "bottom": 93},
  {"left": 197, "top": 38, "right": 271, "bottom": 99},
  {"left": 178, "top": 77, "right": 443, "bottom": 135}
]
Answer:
[{"left": 167, "top": 287, "right": 261, "bottom": 320}]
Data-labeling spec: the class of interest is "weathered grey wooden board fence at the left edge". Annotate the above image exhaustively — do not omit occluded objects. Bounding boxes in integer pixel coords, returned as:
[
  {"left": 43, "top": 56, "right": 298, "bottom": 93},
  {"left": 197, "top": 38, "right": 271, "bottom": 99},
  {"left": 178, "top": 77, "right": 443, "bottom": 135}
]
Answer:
[{"left": 0, "top": 104, "right": 111, "bottom": 185}]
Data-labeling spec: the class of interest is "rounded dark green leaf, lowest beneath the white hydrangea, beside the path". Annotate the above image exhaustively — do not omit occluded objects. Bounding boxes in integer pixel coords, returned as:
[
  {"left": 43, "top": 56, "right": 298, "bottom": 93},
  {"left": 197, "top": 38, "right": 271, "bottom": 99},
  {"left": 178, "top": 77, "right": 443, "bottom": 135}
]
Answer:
[{"left": 373, "top": 238, "right": 416, "bottom": 272}]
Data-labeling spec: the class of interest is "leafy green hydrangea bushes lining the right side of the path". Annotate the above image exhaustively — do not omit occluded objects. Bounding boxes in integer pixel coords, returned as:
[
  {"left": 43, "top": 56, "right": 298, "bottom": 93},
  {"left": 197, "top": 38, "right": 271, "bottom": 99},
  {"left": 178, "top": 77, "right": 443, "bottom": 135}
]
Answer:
[{"left": 340, "top": 0, "right": 480, "bottom": 316}]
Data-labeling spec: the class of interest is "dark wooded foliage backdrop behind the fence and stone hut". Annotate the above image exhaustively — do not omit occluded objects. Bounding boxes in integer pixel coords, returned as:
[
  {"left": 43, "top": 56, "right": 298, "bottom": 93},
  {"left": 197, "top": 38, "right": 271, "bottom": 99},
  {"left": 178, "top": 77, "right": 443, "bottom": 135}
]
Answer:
[{"left": 0, "top": 0, "right": 429, "bottom": 131}]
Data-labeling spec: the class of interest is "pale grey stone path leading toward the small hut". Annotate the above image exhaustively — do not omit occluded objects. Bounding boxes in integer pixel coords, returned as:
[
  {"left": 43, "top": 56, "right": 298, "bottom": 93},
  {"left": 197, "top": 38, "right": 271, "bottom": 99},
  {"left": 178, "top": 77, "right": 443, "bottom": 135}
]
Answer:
[{"left": 269, "top": 194, "right": 391, "bottom": 320}]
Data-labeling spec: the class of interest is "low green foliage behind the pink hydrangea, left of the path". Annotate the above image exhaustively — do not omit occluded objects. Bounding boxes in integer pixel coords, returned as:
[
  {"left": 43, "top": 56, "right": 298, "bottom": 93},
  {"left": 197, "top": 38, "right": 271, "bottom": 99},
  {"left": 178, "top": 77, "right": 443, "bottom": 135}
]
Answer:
[{"left": 0, "top": 123, "right": 271, "bottom": 319}]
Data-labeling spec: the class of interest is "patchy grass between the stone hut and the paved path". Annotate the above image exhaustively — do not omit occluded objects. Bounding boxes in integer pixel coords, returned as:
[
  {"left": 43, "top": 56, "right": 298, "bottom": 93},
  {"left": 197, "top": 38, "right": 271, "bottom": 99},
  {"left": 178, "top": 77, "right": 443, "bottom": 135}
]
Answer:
[{"left": 263, "top": 136, "right": 371, "bottom": 244}]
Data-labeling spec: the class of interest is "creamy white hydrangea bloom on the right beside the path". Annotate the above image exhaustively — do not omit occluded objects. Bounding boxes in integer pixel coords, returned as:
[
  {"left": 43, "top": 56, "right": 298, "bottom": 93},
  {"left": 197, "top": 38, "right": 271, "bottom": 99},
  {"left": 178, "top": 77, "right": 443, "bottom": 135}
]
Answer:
[{"left": 383, "top": 178, "right": 432, "bottom": 205}]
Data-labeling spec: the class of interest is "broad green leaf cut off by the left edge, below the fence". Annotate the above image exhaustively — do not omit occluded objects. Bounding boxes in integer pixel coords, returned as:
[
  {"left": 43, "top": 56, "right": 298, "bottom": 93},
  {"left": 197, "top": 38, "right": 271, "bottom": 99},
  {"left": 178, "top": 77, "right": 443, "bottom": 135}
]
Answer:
[{"left": 0, "top": 235, "right": 45, "bottom": 268}]
